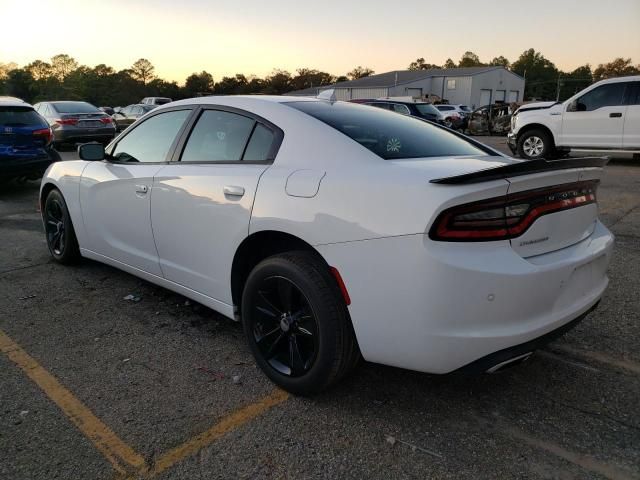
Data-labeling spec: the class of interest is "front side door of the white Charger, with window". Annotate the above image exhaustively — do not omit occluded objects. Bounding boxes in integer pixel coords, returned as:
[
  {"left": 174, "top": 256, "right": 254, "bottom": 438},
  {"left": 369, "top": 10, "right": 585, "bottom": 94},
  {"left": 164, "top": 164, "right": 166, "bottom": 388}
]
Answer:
[{"left": 80, "top": 107, "right": 192, "bottom": 276}]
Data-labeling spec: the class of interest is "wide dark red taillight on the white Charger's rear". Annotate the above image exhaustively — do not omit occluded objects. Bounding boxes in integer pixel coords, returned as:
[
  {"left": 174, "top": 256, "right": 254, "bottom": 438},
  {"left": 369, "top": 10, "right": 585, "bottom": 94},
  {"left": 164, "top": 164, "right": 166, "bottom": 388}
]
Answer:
[{"left": 429, "top": 180, "right": 599, "bottom": 242}]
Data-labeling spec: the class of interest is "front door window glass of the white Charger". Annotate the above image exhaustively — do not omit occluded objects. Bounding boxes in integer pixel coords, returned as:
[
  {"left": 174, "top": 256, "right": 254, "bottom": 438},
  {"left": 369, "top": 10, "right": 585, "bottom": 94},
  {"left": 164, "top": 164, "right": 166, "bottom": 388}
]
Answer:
[{"left": 112, "top": 110, "right": 191, "bottom": 163}]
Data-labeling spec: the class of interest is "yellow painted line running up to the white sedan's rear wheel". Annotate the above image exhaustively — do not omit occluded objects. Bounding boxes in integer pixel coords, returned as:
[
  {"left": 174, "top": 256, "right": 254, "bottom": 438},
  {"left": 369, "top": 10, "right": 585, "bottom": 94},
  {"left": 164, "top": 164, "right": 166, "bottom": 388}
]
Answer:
[{"left": 148, "top": 389, "right": 289, "bottom": 477}]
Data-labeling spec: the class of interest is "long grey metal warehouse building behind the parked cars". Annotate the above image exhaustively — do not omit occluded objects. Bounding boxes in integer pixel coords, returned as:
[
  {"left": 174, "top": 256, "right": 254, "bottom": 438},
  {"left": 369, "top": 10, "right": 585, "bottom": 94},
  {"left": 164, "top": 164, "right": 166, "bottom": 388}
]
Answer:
[{"left": 288, "top": 67, "right": 524, "bottom": 108}]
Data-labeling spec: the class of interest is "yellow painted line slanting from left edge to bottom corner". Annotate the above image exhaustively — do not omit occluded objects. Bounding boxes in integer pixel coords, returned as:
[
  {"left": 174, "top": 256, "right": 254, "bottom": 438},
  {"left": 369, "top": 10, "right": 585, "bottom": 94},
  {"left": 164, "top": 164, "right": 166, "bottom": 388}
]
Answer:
[{"left": 0, "top": 330, "right": 146, "bottom": 474}]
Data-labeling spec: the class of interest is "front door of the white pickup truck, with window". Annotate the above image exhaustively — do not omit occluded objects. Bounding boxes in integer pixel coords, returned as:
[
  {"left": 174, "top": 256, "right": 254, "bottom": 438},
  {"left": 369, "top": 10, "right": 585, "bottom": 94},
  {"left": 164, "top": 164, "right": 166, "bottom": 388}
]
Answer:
[{"left": 559, "top": 82, "right": 628, "bottom": 148}]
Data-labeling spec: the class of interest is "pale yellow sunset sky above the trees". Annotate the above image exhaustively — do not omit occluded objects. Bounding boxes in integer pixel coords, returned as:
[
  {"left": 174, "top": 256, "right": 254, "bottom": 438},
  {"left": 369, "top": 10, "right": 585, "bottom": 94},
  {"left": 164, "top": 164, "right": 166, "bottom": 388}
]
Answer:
[{"left": 0, "top": 0, "right": 640, "bottom": 83}]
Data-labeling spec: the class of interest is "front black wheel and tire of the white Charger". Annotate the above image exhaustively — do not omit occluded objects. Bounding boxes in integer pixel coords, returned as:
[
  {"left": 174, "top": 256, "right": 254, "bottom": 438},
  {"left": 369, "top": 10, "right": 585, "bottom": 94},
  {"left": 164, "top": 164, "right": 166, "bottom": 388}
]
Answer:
[{"left": 42, "top": 189, "right": 80, "bottom": 265}]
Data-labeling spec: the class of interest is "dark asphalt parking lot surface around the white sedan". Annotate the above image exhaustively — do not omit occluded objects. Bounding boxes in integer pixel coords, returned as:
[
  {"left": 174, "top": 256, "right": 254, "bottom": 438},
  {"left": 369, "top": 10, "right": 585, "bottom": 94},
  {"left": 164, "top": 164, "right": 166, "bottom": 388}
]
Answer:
[{"left": 0, "top": 142, "right": 640, "bottom": 480}]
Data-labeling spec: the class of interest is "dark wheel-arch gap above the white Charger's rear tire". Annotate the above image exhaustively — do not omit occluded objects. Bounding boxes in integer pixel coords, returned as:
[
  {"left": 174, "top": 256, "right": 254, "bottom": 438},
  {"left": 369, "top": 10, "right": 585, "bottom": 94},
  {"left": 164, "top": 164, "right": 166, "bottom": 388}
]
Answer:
[{"left": 231, "top": 230, "right": 329, "bottom": 308}]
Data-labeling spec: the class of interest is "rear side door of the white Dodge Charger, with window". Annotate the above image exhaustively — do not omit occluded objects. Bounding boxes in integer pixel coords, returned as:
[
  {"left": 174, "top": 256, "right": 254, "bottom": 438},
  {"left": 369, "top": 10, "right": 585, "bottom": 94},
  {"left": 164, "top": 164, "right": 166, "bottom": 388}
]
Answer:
[{"left": 151, "top": 107, "right": 282, "bottom": 305}]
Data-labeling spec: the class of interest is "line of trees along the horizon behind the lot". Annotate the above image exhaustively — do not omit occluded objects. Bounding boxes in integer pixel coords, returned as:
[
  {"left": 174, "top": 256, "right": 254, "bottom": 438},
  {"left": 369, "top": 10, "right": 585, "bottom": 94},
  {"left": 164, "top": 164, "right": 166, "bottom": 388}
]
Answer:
[{"left": 0, "top": 49, "right": 640, "bottom": 106}]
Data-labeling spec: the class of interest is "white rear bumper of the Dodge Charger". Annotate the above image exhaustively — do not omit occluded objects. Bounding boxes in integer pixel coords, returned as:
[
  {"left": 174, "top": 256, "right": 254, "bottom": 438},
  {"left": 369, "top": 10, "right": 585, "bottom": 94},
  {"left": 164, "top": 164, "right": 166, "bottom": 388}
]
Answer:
[{"left": 316, "top": 222, "right": 613, "bottom": 373}]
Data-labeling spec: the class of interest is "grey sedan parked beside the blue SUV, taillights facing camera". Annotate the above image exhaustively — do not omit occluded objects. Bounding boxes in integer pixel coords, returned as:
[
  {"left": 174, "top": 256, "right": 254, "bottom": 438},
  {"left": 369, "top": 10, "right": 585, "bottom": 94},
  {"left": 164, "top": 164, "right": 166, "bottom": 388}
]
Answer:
[{"left": 34, "top": 101, "right": 116, "bottom": 145}]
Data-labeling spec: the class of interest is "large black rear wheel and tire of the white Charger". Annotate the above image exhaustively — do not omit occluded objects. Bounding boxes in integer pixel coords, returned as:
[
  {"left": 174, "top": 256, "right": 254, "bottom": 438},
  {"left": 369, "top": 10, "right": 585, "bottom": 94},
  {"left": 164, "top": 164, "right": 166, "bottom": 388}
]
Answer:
[{"left": 242, "top": 252, "right": 360, "bottom": 395}]
